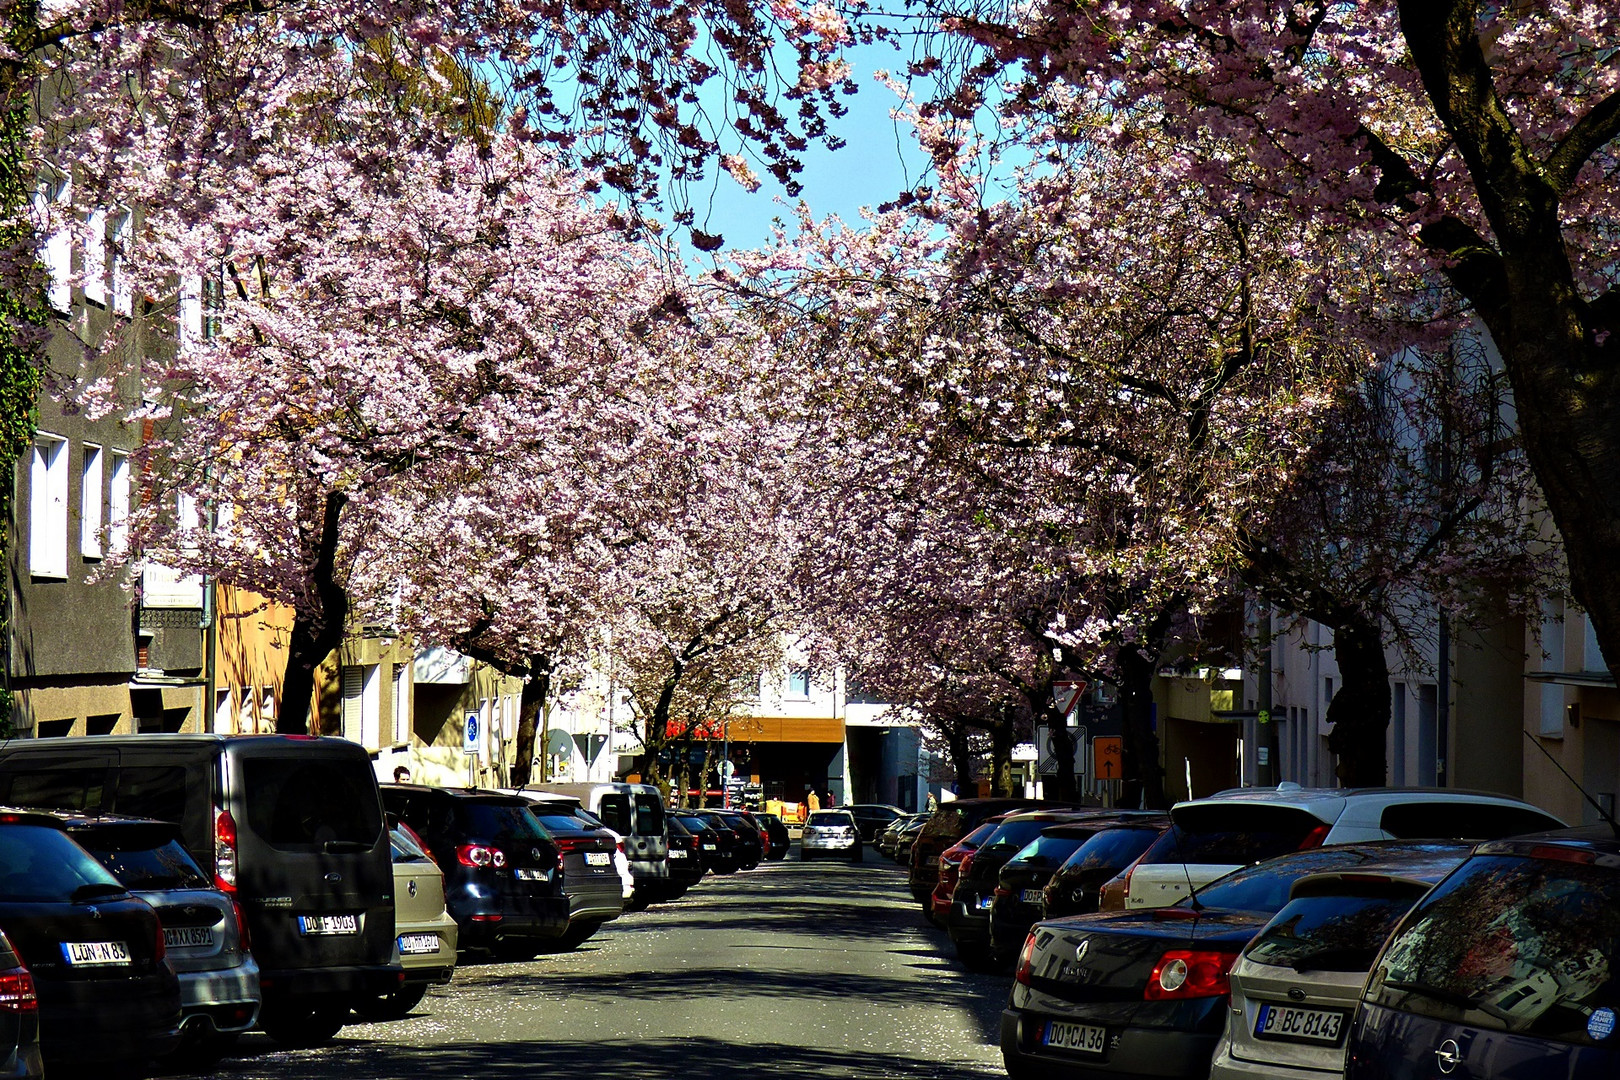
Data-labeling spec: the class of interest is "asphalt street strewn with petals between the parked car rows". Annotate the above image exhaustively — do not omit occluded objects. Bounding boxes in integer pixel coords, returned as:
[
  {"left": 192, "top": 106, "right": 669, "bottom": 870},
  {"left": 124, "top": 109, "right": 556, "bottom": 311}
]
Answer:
[{"left": 180, "top": 850, "right": 1008, "bottom": 1080}]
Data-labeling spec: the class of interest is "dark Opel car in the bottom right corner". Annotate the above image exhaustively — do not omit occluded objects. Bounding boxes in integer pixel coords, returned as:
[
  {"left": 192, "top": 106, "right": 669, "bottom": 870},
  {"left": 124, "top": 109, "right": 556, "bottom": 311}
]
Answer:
[{"left": 1345, "top": 826, "right": 1620, "bottom": 1080}]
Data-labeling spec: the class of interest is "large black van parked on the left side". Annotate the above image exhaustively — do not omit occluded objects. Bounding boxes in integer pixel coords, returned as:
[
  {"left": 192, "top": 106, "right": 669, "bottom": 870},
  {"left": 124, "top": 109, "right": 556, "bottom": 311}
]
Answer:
[{"left": 0, "top": 735, "right": 403, "bottom": 1046}]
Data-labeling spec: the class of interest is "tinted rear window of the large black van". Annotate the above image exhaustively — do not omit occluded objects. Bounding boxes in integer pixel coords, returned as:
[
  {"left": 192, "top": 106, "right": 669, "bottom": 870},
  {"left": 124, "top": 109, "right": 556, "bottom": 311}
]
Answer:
[{"left": 241, "top": 758, "right": 382, "bottom": 852}]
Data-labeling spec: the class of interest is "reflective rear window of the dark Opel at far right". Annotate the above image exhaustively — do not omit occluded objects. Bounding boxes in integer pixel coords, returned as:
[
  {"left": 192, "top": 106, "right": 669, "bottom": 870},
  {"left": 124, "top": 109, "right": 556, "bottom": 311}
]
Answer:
[{"left": 1367, "top": 855, "right": 1620, "bottom": 1044}]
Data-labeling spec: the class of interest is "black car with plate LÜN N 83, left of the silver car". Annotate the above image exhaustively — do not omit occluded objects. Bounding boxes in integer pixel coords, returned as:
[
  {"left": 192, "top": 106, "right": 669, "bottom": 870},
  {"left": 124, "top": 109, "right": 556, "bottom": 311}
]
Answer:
[{"left": 0, "top": 811, "right": 181, "bottom": 1072}]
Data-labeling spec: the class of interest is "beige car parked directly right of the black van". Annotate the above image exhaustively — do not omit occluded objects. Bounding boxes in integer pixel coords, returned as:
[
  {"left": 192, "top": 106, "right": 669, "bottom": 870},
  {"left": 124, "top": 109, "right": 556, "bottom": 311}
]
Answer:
[{"left": 355, "top": 821, "right": 458, "bottom": 1020}]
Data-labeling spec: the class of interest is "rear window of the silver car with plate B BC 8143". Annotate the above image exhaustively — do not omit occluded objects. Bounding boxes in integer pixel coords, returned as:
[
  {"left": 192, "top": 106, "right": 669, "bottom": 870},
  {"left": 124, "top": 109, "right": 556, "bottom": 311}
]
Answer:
[{"left": 1247, "top": 889, "right": 1421, "bottom": 972}]
